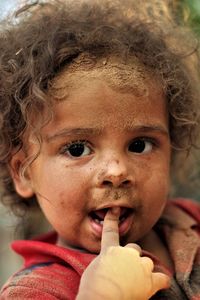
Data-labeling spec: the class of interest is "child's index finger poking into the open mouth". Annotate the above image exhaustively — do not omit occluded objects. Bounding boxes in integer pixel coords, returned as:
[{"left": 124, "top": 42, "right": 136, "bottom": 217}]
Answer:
[{"left": 101, "top": 207, "right": 120, "bottom": 253}]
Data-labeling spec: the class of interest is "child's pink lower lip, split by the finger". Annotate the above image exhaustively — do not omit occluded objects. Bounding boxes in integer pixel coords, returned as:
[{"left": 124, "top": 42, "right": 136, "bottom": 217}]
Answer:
[{"left": 90, "top": 215, "right": 133, "bottom": 238}]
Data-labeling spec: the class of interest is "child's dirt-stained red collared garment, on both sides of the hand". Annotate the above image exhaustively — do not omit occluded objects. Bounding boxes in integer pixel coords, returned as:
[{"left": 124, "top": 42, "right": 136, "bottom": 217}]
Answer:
[{"left": 0, "top": 199, "right": 200, "bottom": 300}]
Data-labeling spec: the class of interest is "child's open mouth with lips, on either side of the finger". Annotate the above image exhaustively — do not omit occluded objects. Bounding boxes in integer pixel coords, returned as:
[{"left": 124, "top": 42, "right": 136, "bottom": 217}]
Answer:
[{"left": 89, "top": 207, "right": 133, "bottom": 236}]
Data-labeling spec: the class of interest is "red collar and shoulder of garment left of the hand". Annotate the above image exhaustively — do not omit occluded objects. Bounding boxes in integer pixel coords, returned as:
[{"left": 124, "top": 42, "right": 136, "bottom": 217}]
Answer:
[{"left": 0, "top": 233, "right": 95, "bottom": 299}]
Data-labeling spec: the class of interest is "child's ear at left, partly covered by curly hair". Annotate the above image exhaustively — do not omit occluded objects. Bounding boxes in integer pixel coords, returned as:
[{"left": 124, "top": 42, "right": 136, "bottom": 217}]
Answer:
[{"left": 9, "top": 149, "right": 34, "bottom": 198}]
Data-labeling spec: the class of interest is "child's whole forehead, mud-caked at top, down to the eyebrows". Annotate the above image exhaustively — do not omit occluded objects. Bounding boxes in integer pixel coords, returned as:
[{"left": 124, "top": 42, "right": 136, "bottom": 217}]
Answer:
[{"left": 44, "top": 65, "right": 167, "bottom": 135}]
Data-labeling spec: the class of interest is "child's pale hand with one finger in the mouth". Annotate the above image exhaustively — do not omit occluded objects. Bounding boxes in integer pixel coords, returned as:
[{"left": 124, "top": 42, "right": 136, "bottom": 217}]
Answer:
[{"left": 76, "top": 208, "right": 170, "bottom": 300}]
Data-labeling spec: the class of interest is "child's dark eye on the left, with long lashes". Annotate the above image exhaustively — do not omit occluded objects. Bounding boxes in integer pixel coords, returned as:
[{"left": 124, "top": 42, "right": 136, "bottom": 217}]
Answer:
[{"left": 61, "top": 141, "right": 92, "bottom": 157}]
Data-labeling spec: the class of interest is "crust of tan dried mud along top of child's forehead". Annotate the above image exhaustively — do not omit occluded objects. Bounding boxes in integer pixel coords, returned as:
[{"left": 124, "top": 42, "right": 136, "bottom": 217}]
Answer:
[{"left": 50, "top": 54, "right": 160, "bottom": 100}]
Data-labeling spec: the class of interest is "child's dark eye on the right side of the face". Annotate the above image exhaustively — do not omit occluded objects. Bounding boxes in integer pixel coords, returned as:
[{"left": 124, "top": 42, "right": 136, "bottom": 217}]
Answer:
[{"left": 128, "top": 138, "right": 153, "bottom": 154}]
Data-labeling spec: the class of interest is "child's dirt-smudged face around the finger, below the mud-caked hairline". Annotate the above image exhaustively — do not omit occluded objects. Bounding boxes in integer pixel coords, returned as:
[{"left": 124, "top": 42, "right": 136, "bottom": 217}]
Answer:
[{"left": 12, "top": 69, "right": 170, "bottom": 252}]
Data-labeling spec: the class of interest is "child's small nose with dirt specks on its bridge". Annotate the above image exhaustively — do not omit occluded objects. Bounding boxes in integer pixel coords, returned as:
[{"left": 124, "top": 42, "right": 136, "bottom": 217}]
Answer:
[{"left": 98, "top": 159, "right": 133, "bottom": 187}]
